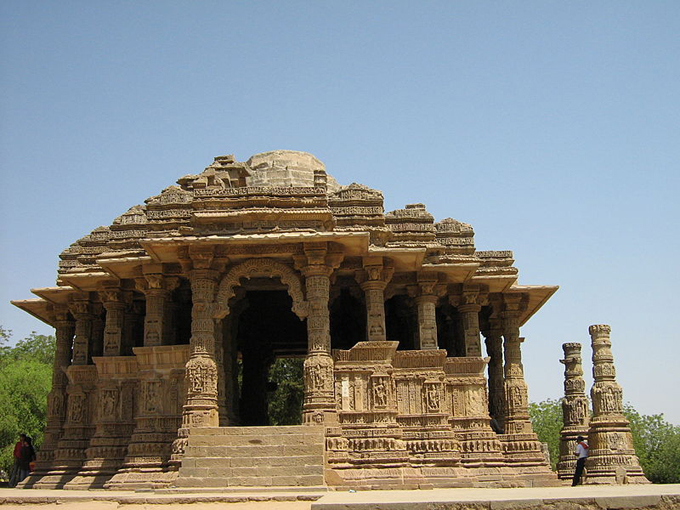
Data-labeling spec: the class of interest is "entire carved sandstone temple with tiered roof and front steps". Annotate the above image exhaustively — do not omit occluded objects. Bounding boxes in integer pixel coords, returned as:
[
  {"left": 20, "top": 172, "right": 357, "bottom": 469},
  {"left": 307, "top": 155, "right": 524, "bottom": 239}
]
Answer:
[{"left": 14, "top": 151, "right": 558, "bottom": 489}]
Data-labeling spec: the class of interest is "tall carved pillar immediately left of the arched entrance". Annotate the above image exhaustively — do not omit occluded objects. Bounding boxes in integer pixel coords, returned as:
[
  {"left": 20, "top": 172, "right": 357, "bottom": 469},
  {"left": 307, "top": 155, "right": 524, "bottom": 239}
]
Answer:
[{"left": 172, "top": 260, "right": 219, "bottom": 467}]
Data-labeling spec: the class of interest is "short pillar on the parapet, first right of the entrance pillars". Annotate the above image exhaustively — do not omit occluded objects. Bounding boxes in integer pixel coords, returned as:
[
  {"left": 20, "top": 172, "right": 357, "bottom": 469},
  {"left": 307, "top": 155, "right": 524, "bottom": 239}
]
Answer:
[{"left": 356, "top": 257, "right": 394, "bottom": 342}]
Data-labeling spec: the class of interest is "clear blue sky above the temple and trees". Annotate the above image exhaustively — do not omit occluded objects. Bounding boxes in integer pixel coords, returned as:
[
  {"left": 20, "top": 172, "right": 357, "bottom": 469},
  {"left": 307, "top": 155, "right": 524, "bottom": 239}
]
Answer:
[{"left": 0, "top": 0, "right": 680, "bottom": 424}]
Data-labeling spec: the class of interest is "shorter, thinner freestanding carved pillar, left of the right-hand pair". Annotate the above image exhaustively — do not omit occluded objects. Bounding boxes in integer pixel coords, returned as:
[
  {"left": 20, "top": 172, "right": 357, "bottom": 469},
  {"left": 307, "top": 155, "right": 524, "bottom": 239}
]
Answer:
[{"left": 557, "top": 343, "right": 590, "bottom": 480}]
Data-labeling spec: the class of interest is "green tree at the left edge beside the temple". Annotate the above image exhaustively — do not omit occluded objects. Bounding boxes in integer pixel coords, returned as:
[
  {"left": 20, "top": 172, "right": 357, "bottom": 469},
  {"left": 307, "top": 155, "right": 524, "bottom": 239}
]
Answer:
[{"left": 0, "top": 326, "right": 55, "bottom": 472}]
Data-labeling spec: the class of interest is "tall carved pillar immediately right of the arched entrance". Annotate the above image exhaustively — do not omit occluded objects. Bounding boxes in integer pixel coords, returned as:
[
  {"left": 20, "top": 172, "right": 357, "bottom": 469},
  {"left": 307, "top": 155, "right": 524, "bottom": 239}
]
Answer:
[{"left": 296, "top": 243, "right": 342, "bottom": 425}]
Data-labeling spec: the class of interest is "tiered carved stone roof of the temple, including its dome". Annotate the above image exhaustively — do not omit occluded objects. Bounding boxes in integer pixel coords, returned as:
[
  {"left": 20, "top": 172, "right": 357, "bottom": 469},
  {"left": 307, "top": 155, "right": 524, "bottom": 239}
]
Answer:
[{"left": 58, "top": 150, "right": 517, "bottom": 284}]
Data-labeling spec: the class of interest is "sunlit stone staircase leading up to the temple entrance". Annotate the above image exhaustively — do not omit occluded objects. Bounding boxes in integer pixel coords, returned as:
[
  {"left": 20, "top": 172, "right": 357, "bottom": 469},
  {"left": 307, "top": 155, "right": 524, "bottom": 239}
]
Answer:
[{"left": 175, "top": 425, "right": 325, "bottom": 488}]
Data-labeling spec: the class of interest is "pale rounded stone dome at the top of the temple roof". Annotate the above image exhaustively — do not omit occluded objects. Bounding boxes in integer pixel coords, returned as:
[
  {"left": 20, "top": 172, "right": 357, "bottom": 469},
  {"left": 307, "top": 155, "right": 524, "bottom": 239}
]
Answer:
[{"left": 247, "top": 150, "right": 340, "bottom": 192}]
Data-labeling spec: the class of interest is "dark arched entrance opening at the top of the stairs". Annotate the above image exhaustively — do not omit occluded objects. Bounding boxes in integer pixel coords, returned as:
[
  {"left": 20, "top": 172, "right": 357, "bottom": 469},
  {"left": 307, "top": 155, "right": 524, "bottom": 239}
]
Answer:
[{"left": 235, "top": 286, "right": 307, "bottom": 426}]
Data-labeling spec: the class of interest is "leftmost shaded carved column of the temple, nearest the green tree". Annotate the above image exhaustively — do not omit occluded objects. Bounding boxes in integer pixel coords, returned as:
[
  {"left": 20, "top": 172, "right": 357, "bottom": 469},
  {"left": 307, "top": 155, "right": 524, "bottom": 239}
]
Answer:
[{"left": 34, "top": 305, "right": 75, "bottom": 475}]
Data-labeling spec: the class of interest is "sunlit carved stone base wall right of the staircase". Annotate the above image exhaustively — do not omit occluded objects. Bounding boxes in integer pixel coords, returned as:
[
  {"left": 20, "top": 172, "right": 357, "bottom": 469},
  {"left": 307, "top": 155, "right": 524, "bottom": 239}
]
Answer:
[{"left": 326, "top": 341, "right": 557, "bottom": 488}]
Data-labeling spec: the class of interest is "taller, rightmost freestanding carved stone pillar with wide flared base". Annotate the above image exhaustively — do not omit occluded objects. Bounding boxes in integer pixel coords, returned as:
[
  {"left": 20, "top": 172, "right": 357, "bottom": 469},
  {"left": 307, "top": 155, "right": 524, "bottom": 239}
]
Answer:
[{"left": 584, "top": 324, "right": 649, "bottom": 485}]
